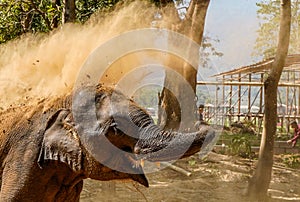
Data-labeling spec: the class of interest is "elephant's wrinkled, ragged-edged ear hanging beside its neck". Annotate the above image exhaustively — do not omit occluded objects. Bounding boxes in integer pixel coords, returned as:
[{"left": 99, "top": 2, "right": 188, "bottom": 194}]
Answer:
[{"left": 38, "top": 109, "right": 83, "bottom": 172}]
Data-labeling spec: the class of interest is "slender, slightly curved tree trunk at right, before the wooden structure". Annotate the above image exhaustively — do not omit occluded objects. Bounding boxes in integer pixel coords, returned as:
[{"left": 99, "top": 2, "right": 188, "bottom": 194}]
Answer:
[{"left": 248, "top": 0, "right": 291, "bottom": 201}]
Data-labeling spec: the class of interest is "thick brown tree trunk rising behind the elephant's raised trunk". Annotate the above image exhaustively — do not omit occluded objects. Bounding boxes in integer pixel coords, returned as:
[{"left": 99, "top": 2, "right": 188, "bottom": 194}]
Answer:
[{"left": 159, "top": 0, "right": 210, "bottom": 129}]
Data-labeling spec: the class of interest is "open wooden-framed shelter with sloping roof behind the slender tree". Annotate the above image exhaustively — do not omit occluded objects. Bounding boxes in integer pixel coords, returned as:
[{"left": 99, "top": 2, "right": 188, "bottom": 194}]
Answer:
[{"left": 197, "top": 54, "right": 300, "bottom": 133}]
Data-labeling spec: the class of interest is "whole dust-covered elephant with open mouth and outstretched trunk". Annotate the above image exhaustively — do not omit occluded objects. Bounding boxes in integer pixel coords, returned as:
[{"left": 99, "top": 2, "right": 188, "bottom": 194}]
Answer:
[{"left": 0, "top": 84, "right": 214, "bottom": 202}]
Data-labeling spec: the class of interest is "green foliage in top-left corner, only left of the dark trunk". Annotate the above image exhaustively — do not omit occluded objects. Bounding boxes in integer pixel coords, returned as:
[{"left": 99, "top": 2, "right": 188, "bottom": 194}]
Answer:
[{"left": 0, "top": 0, "right": 62, "bottom": 43}]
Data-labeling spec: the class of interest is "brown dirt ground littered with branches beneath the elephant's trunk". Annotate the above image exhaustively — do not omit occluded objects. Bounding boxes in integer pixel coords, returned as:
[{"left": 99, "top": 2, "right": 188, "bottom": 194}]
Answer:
[{"left": 81, "top": 152, "right": 300, "bottom": 202}]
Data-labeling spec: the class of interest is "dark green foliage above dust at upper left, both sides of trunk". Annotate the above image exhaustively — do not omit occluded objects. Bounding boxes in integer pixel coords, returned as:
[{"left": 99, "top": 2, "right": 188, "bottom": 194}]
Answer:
[{"left": 0, "top": 0, "right": 119, "bottom": 43}]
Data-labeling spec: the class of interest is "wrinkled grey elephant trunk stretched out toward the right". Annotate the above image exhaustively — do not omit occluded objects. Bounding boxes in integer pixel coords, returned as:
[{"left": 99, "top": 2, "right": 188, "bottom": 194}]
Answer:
[{"left": 134, "top": 124, "right": 215, "bottom": 161}]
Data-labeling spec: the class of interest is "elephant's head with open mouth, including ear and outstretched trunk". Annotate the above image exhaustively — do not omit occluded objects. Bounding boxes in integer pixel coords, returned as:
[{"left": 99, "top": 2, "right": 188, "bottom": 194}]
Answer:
[{"left": 38, "top": 85, "right": 214, "bottom": 186}]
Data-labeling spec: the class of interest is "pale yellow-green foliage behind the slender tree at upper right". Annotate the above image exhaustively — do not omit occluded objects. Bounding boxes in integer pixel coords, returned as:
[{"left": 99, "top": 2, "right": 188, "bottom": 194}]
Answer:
[{"left": 253, "top": 0, "right": 300, "bottom": 58}]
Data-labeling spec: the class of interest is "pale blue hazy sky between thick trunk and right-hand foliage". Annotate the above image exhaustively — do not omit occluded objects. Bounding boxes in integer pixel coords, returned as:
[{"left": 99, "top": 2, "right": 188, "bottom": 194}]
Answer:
[{"left": 204, "top": 0, "right": 260, "bottom": 72}]
